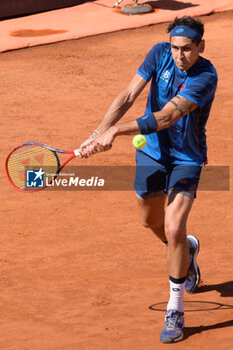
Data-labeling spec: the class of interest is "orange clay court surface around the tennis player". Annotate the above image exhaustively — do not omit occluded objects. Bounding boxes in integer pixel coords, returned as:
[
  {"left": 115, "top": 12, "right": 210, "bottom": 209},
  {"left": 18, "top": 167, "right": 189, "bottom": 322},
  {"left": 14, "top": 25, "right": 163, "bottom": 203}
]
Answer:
[{"left": 0, "top": 12, "right": 233, "bottom": 350}]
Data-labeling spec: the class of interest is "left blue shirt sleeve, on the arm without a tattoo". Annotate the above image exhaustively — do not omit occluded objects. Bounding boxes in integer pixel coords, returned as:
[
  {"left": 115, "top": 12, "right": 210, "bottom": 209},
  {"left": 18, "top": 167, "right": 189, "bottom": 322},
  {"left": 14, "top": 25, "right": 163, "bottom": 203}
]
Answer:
[{"left": 137, "top": 42, "right": 167, "bottom": 82}]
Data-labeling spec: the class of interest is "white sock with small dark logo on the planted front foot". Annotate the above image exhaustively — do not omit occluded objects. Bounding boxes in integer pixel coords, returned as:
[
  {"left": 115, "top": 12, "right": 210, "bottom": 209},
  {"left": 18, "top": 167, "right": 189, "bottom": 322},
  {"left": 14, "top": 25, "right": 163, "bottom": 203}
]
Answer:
[{"left": 167, "top": 280, "right": 185, "bottom": 312}]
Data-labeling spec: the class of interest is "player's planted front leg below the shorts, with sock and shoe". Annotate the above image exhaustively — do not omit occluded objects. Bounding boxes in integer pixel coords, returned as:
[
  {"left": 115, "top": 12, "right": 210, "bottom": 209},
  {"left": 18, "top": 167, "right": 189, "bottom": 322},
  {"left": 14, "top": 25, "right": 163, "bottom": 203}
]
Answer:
[{"left": 160, "top": 192, "right": 193, "bottom": 343}]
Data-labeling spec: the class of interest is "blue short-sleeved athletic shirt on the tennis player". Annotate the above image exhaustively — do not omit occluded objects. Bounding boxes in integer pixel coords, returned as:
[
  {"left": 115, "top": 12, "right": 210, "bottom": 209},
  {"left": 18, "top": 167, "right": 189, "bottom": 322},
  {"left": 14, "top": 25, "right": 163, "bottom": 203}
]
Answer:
[{"left": 137, "top": 42, "right": 218, "bottom": 165}]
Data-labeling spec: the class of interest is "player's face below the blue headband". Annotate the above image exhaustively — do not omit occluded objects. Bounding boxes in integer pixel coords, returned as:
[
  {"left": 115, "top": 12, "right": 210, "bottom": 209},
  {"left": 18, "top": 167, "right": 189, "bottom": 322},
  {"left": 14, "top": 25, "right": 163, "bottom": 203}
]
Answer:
[{"left": 171, "top": 36, "right": 204, "bottom": 72}]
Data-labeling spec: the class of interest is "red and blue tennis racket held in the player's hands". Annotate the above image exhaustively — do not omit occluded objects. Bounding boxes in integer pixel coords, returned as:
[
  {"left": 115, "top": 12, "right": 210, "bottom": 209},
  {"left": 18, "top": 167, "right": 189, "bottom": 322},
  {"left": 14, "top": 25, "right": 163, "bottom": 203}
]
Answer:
[{"left": 5, "top": 142, "right": 80, "bottom": 192}]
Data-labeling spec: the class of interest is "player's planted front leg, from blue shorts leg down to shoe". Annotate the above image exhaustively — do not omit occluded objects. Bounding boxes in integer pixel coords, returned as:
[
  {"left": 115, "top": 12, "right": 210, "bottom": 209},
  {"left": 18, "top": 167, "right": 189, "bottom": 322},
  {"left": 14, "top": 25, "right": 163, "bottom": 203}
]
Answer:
[{"left": 160, "top": 165, "right": 201, "bottom": 343}]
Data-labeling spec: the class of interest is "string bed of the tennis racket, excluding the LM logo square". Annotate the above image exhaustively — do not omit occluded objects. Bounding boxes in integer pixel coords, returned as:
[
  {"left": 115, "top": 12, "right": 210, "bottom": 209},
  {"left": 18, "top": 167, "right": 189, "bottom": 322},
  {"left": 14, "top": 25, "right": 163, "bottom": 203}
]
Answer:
[{"left": 7, "top": 145, "right": 59, "bottom": 190}]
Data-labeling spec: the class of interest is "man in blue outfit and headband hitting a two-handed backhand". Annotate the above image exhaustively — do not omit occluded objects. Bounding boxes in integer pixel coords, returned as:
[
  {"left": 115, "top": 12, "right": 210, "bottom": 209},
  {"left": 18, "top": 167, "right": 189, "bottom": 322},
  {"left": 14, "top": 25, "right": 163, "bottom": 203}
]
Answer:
[{"left": 81, "top": 17, "right": 217, "bottom": 343}]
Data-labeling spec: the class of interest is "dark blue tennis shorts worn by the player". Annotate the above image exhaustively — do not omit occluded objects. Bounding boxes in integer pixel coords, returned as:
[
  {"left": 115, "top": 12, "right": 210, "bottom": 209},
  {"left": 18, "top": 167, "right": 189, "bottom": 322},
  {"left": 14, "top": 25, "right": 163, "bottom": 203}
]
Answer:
[{"left": 134, "top": 150, "right": 202, "bottom": 199}]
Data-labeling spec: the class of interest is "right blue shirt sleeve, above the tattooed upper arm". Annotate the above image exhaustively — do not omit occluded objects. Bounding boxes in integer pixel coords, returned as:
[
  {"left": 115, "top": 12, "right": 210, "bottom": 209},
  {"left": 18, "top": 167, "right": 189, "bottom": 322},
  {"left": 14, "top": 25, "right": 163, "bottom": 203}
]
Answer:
[{"left": 178, "top": 70, "right": 218, "bottom": 108}]
